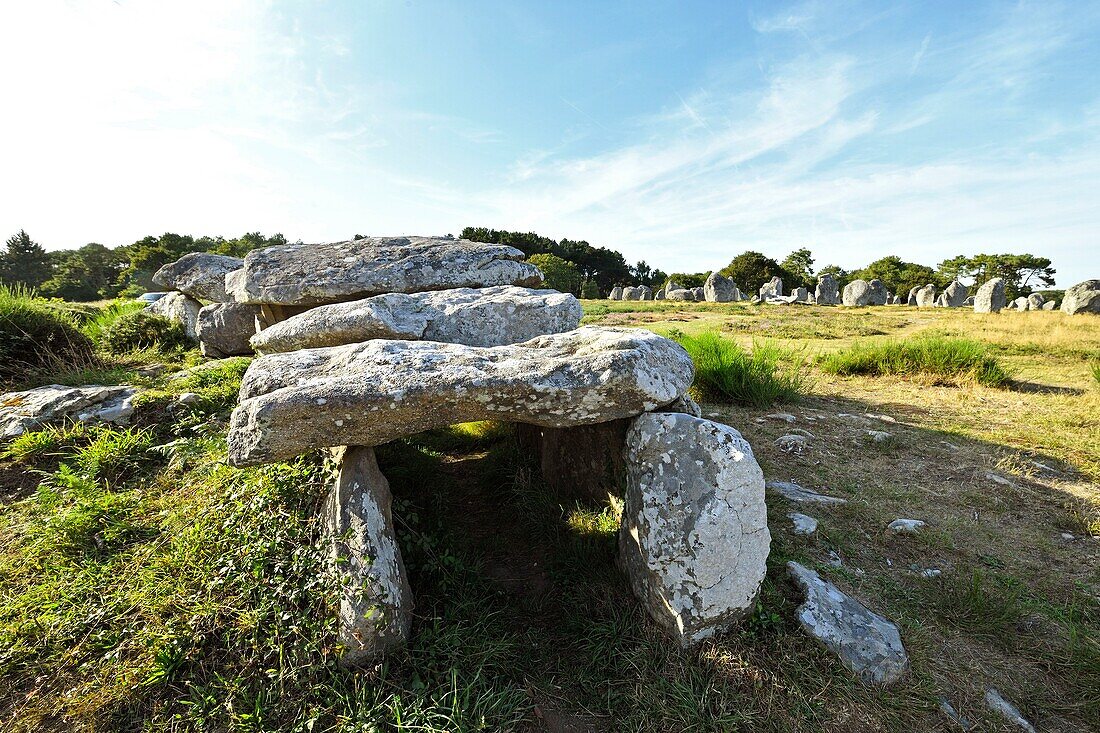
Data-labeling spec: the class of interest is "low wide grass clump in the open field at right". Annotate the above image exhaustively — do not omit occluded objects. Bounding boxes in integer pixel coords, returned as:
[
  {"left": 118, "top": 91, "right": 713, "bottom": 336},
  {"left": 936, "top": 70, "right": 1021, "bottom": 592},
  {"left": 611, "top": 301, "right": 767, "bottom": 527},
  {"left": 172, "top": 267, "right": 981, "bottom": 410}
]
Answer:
[{"left": 818, "top": 337, "right": 1012, "bottom": 387}]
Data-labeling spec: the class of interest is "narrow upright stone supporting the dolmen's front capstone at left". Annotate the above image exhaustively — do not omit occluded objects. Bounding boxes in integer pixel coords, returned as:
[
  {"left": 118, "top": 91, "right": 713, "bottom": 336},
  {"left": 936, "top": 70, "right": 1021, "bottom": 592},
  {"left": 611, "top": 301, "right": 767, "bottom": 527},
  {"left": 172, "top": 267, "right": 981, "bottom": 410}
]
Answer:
[{"left": 321, "top": 447, "right": 413, "bottom": 665}]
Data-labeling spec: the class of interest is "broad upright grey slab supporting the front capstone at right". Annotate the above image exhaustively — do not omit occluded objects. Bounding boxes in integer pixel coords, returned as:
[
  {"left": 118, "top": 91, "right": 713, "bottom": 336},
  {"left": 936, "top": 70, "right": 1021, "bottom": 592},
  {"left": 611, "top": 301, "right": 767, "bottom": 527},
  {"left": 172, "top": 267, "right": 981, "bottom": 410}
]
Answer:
[{"left": 619, "top": 413, "right": 771, "bottom": 647}]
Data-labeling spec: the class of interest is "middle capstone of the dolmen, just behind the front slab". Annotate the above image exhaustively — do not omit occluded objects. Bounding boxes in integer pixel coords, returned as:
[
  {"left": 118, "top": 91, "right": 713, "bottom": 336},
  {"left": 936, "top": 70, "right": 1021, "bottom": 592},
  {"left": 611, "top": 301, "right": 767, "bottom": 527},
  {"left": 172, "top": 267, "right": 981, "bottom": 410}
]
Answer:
[{"left": 245, "top": 285, "right": 584, "bottom": 353}]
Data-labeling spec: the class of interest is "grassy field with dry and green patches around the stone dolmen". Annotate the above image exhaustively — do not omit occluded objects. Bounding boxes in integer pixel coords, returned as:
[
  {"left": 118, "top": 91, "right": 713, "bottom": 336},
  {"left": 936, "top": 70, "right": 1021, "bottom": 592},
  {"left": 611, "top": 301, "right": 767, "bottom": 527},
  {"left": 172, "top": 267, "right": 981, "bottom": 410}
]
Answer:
[{"left": 0, "top": 300, "right": 1100, "bottom": 732}]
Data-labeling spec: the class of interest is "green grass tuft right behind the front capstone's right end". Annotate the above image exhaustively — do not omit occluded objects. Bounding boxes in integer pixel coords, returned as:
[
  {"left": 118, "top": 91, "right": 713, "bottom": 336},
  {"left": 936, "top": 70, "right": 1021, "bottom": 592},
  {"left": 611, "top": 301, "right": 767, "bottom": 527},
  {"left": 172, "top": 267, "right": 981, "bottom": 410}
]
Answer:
[{"left": 671, "top": 331, "right": 805, "bottom": 407}]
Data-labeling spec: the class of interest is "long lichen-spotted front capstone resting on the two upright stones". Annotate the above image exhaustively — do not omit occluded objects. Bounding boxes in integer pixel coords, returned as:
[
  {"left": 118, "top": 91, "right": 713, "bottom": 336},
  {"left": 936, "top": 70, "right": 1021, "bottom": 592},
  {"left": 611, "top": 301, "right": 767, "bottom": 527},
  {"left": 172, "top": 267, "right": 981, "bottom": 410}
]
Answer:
[{"left": 229, "top": 326, "right": 694, "bottom": 466}]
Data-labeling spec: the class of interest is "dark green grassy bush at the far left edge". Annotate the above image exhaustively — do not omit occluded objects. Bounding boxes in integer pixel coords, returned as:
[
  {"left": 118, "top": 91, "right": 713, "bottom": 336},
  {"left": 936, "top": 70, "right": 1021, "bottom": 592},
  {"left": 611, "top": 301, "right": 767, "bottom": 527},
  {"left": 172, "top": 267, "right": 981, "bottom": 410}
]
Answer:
[{"left": 0, "top": 285, "right": 94, "bottom": 382}]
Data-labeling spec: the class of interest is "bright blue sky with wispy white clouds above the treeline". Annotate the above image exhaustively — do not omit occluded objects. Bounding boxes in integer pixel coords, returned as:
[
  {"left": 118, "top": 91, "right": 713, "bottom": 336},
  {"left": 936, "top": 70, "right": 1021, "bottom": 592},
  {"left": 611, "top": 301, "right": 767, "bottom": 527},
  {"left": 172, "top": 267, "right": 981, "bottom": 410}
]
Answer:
[{"left": 0, "top": 0, "right": 1100, "bottom": 286}]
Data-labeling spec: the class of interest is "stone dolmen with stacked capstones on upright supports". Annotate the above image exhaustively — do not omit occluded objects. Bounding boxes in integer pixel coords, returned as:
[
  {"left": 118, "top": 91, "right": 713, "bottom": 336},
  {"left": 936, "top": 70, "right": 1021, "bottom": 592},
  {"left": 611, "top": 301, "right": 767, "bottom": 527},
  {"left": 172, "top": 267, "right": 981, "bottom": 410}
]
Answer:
[{"left": 212, "top": 234, "right": 770, "bottom": 665}]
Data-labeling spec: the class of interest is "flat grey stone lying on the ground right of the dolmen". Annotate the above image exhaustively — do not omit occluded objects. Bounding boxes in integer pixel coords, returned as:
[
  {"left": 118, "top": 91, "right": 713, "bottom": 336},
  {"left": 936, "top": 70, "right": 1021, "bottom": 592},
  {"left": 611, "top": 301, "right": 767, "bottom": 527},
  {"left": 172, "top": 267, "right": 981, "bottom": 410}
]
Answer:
[{"left": 787, "top": 561, "right": 909, "bottom": 685}]
